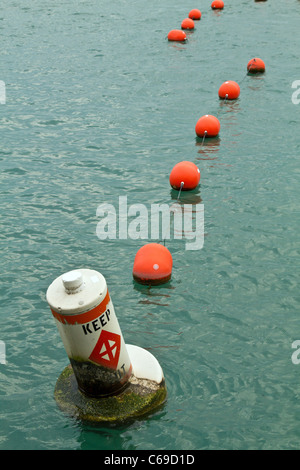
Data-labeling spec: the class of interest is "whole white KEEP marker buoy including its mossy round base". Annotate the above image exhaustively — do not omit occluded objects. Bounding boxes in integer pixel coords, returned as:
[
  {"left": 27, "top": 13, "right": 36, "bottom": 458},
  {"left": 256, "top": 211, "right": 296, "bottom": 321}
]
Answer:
[{"left": 46, "top": 269, "right": 167, "bottom": 424}]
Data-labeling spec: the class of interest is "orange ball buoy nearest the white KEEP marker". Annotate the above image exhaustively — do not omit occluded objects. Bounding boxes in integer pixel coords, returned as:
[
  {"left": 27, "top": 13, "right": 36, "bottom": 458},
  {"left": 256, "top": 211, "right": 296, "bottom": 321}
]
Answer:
[{"left": 132, "top": 243, "right": 173, "bottom": 285}]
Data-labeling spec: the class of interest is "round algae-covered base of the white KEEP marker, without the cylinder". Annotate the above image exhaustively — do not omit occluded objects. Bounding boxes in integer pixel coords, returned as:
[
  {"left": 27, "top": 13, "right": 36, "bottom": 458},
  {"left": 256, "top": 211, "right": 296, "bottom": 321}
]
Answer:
[{"left": 54, "top": 345, "right": 167, "bottom": 425}]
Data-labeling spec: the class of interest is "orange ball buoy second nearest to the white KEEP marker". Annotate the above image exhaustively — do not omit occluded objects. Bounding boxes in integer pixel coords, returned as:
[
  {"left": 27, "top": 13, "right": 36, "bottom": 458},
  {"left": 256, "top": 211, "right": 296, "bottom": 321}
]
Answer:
[{"left": 169, "top": 161, "right": 201, "bottom": 191}]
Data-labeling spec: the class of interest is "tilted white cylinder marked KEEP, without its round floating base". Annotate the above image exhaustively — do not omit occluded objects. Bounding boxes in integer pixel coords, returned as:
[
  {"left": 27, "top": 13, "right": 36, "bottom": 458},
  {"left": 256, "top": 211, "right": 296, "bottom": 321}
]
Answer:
[{"left": 47, "top": 269, "right": 132, "bottom": 397}]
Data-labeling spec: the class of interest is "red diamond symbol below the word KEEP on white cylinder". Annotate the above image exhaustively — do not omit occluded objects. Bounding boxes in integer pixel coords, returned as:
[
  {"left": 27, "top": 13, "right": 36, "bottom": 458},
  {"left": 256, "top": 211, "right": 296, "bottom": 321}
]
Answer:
[{"left": 89, "top": 330, "right": 121, "bottom": 369}]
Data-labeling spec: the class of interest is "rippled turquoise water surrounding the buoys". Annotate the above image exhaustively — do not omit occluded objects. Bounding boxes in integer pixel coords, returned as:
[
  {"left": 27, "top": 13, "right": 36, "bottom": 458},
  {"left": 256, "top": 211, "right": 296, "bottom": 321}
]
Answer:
[{"left": 0, "top": 0, "right": 300, "bottom": 450}]
